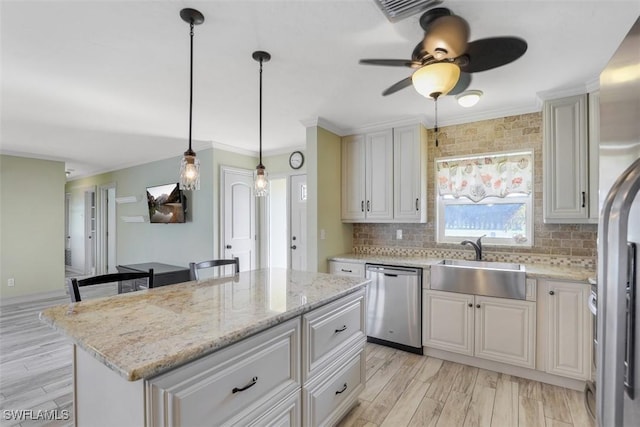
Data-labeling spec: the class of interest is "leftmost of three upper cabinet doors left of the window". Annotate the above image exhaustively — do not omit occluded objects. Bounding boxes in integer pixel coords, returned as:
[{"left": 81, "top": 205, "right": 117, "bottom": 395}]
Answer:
[{"left": 342, "top": 135, "right": 366, "bottom": 221}]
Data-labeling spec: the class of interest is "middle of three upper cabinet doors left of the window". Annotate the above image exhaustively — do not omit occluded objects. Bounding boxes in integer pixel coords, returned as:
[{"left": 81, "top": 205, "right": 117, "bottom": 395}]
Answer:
[{"left": 365, "top": 129, "right": 393, "bottom": 221}]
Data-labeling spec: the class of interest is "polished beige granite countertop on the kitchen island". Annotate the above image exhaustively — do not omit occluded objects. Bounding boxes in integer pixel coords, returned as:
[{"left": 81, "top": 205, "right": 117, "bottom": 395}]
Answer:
[{"left": 40, "top": 269, "right": 367, "bottom": 381}]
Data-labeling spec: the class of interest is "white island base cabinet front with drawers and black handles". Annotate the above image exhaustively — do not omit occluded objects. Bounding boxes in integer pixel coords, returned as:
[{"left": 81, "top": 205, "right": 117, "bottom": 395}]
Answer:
[{"left": 145, "top": 289, "right": 366, "bottom": 427}]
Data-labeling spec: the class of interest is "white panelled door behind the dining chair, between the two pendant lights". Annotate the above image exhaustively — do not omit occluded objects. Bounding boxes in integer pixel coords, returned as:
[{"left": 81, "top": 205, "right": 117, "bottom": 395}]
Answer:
[{"left": 220, "top": 167, "right": 256, "bottom": 271}]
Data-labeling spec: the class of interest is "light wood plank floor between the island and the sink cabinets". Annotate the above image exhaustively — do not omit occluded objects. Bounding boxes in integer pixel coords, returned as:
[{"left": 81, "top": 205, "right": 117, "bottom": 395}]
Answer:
[{"left": 339, "top": 343, "right": 594, "bottom": 427}]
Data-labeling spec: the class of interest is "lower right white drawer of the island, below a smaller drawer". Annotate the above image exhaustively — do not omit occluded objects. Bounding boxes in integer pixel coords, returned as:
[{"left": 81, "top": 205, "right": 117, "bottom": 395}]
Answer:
[{"left": 302, "top": 348, "right": 366, "bottom": 426}]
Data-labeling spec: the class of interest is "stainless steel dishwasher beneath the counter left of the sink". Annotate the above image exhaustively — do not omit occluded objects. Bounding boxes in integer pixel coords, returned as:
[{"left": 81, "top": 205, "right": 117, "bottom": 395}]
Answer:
[{"left": 366, "top": 264, "right": 422, "bottom": 354}]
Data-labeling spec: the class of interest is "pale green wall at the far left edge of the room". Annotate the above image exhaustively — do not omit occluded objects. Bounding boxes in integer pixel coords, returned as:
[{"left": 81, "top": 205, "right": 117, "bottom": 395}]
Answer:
[{"left": 0, "top": 155, "right": 66, "bottom": 298}]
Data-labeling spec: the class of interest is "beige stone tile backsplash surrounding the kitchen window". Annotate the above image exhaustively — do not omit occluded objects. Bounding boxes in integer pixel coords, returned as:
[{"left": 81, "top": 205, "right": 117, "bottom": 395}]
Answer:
[{"left": 353, "top": 113, "right": 598, "bottom": 268}]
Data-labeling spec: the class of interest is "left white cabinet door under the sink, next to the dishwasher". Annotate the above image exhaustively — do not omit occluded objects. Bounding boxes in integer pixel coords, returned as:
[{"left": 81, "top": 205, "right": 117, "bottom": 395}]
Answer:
[{"left": 422, "top": 290, "right": 474, "bottom": 356}]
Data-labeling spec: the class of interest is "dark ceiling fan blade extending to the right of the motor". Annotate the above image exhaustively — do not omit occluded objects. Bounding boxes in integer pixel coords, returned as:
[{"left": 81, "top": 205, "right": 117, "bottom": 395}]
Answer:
[{"left": 460, "top": 37, "right": 527, "bottom": 73}]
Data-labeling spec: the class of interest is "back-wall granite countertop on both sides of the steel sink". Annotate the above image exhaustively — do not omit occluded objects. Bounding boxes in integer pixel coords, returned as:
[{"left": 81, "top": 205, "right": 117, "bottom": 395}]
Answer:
[{"left": 329, "top": 254, "right": 596, "bottom": 283}]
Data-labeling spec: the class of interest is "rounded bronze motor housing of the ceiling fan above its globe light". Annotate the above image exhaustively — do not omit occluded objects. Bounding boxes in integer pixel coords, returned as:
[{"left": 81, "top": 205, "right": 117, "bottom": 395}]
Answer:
[{"left": 424, "top": 15, "right": 469, "bottom": 60}]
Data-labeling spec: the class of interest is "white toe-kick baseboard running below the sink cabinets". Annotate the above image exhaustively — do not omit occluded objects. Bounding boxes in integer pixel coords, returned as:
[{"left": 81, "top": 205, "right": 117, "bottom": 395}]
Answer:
[{"left": 424, "top": 347, "right": 586, "bottom": 391}]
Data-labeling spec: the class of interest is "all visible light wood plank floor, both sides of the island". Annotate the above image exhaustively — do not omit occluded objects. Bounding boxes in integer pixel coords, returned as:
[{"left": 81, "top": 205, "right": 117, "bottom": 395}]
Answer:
[{"left": 0, "top": 285, "right": 594, "bottom": 427}]
